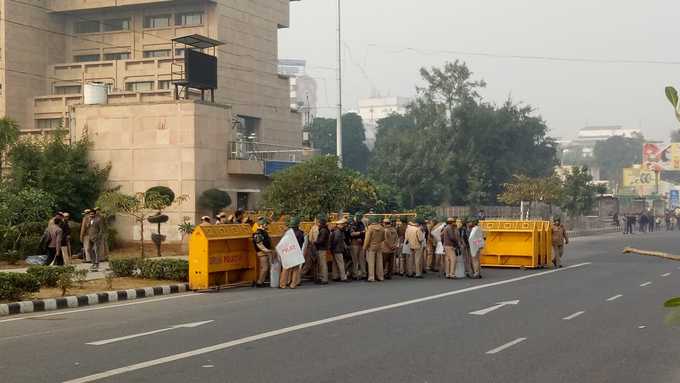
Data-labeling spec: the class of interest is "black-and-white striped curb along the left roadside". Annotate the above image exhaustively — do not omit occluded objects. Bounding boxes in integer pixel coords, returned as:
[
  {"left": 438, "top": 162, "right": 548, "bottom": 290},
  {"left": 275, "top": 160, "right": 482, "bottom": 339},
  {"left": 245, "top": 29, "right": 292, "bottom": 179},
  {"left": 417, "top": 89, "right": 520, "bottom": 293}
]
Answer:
[{"left": 0, "top": 283, "right": 190, "bottom": 317}]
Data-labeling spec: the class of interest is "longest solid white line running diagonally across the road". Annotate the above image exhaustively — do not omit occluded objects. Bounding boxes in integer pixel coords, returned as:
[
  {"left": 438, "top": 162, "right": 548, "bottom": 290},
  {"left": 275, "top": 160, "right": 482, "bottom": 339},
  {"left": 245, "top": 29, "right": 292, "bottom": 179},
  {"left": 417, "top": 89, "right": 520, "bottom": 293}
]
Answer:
[{"left": 64, "top": 262, "right": 591, "bottom": 383}]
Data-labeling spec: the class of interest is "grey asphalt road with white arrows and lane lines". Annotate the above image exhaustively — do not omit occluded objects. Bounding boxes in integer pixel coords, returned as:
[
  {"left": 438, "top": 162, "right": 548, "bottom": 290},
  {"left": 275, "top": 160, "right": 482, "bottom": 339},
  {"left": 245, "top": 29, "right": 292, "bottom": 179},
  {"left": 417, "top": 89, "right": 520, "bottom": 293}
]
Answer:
[{"left": 0, "top": 232, "right": 680, "bottom": 383}]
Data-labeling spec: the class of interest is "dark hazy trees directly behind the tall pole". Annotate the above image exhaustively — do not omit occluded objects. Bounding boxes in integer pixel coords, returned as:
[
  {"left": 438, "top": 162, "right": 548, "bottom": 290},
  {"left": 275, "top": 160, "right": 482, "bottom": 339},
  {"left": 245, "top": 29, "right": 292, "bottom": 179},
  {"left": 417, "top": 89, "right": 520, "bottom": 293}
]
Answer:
[{"left": 310, "top": 113, "right": 370, "bottom": 173}]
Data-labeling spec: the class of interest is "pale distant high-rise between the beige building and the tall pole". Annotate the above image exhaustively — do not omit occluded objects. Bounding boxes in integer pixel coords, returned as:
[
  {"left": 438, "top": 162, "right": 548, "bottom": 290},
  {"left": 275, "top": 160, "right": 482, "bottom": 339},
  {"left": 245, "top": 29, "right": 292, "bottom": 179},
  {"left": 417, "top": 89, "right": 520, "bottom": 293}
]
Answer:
[{"left": 279, "top": 59, "right": 318, "bottom": 127}]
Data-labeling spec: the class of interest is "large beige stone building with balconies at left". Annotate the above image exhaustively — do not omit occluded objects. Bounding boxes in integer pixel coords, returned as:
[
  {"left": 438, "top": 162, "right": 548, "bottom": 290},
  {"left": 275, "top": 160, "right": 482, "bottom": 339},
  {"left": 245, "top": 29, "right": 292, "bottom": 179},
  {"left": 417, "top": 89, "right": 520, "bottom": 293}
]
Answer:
[{"left": 0, "top": 0, "right": 307, "bottom": 240}]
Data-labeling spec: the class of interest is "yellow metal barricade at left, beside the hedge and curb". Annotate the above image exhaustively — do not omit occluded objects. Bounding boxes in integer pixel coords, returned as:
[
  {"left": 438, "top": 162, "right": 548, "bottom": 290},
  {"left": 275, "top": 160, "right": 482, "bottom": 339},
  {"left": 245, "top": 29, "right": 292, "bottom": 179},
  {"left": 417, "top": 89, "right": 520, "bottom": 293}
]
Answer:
[{"left": 189, "top": 225, "right": 257, "bottom": 290}]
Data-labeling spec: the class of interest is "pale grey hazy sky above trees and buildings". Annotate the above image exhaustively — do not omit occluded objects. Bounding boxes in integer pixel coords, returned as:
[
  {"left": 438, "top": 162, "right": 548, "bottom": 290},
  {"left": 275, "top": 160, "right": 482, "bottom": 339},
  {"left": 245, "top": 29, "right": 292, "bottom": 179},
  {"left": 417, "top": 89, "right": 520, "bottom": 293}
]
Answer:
[{"left": 279, "top": 0, "right": 680, "bottom": 140}]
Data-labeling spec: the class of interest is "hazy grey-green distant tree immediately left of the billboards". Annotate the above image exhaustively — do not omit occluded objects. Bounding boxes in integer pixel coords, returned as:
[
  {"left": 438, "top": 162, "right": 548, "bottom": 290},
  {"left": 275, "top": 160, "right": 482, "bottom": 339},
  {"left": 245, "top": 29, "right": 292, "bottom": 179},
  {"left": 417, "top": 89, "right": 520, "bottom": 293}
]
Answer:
[{"left": 593, "top": 135, "right": 645, "bottom": 184}]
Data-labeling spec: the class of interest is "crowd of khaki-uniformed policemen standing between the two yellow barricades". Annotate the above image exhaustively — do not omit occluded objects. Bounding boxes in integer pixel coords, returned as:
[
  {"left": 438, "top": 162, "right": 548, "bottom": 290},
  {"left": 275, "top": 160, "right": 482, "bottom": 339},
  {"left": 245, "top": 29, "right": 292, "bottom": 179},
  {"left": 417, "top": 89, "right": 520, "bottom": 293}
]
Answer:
[{"left": 253, "top": 214, "right": 484, "bottom": 289}]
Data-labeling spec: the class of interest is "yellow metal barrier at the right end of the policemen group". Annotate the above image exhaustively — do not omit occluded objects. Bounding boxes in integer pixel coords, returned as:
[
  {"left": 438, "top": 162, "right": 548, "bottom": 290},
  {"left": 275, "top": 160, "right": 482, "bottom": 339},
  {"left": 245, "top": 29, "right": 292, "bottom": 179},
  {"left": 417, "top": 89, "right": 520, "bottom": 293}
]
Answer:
[{"left": 480, "top": 221, "right": 552, "bottom": 268}]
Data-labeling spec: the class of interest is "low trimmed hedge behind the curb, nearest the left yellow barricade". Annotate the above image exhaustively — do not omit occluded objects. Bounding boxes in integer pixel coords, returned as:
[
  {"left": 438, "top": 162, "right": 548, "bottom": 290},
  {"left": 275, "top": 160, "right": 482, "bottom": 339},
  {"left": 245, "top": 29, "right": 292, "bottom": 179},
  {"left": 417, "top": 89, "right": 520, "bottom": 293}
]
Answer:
[{"left": 109, "top": 258, "right": 189, "bottom": 282}]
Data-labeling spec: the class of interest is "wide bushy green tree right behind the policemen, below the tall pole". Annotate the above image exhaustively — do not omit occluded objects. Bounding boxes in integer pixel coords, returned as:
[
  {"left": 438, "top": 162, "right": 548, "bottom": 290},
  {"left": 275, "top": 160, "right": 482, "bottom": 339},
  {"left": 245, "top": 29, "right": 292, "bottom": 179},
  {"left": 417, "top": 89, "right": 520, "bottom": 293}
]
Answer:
[{"left": 263, "top": 156, "right": 378, "bottom": 219}]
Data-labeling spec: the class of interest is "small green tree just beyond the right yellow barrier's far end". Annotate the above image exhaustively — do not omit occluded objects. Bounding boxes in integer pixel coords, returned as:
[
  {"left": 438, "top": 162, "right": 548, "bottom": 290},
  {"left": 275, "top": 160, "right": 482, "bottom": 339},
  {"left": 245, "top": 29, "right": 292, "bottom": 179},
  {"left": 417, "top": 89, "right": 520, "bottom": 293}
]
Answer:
[{"left": 560, "top": 166, "right": 599, "bottom": 217}]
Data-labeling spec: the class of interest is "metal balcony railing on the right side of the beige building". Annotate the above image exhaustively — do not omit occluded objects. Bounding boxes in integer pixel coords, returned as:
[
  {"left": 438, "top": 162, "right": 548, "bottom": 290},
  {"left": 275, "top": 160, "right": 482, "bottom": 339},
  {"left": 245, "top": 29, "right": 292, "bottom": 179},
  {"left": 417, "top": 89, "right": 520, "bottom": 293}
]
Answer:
[{"left": 229, "top": 141, "right": 315, "bottom": 162}]
